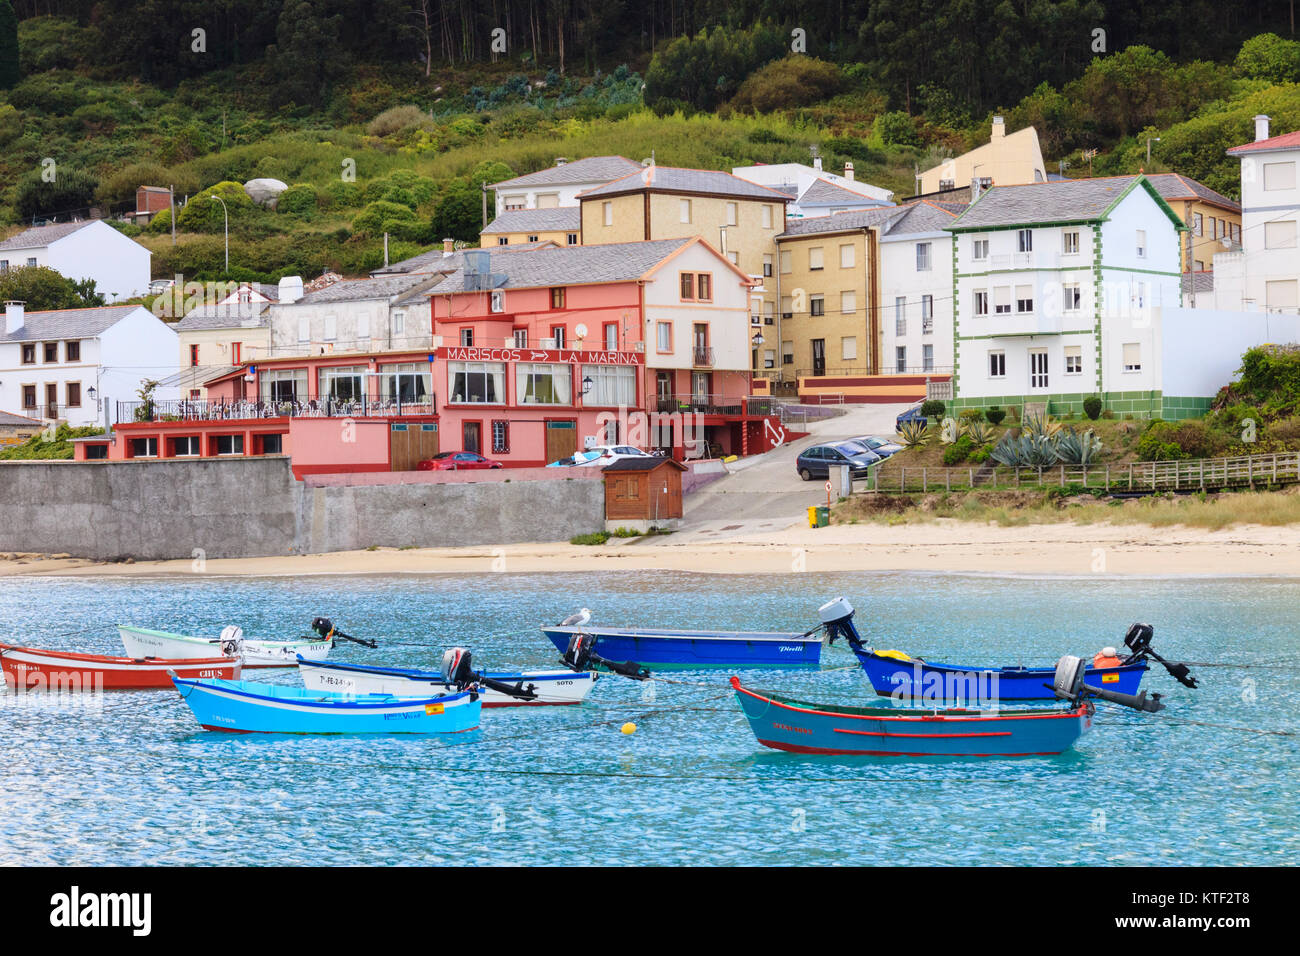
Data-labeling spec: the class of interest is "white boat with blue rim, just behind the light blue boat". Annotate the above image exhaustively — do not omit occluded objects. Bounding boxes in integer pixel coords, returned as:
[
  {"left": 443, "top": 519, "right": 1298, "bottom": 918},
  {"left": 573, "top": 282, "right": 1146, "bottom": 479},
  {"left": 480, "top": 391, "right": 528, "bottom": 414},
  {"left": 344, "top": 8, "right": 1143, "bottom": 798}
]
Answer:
[{"left": 298, "top": 659, "right": 598, "bottom": 708}]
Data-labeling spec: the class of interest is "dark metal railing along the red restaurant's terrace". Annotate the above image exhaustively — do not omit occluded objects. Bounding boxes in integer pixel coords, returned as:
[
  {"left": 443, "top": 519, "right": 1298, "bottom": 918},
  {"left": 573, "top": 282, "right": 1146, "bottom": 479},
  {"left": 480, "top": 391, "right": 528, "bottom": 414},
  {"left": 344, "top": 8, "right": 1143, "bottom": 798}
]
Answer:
[{"left": 117, "top": 394, "right": 438, "bottom": 421}]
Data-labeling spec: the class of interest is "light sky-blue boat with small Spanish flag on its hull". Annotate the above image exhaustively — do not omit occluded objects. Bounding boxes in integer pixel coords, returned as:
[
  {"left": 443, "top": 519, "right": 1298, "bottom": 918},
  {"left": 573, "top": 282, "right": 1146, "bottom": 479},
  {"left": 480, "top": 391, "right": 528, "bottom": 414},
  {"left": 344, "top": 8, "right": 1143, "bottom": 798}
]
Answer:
[{"left": 172, "top": 678, "right": 482, "bottom": 734}]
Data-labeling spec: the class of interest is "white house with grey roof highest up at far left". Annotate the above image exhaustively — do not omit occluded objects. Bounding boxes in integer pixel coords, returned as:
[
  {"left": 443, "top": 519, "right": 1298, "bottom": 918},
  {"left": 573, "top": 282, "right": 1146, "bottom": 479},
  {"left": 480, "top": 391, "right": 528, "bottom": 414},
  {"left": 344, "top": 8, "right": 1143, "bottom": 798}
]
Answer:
[{"left": 0, "top": 220, "right": 153, "bottom": 303}]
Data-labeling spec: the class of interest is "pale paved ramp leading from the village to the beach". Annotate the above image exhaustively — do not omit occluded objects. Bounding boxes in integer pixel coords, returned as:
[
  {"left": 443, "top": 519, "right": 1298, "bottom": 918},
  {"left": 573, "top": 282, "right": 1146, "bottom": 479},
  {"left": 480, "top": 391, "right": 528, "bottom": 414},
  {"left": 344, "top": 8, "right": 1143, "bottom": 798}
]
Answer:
[{"left": 645, "top": 405, "right": 907, "bottom": 544}]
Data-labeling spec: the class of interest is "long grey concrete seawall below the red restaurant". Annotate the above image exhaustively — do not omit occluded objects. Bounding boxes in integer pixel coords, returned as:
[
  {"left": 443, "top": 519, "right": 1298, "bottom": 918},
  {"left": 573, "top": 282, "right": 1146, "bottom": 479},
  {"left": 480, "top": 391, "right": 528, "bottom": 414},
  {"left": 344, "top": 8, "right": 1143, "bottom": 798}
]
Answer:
[{"left": 0, "top": 457, "right": 605, "bottom": 561}]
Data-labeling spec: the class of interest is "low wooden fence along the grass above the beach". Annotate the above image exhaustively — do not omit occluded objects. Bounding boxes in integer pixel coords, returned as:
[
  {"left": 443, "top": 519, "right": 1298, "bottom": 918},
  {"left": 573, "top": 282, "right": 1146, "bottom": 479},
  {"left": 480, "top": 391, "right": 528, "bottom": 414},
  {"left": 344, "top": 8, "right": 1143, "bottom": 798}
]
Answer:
[{"left": 866, "top": 451, "right": 1300, "bottom": 493}]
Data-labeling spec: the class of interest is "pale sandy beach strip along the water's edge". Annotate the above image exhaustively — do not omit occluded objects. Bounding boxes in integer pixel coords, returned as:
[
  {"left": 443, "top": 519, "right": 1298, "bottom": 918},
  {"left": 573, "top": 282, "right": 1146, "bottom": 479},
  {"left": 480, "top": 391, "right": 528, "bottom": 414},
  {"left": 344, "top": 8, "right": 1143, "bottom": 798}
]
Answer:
[{"left": 0, "top": 520, "right": 1300, "bottom": 578}]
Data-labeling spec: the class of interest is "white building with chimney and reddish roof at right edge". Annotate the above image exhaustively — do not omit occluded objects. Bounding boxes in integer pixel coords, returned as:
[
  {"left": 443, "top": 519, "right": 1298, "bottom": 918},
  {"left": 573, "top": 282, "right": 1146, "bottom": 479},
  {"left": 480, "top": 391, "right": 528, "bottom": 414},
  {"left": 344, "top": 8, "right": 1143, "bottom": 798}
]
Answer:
[{"left": 1213, "top": 116, "right": 1300, "bottom": 313}]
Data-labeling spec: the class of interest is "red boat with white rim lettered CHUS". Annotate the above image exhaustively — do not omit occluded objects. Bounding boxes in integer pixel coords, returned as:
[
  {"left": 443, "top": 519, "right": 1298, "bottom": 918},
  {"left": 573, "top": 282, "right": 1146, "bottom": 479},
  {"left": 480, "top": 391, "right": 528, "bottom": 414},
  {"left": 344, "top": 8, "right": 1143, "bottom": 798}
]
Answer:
[{"left": 0, "top": 644, "right": 243, "bottom": 691}]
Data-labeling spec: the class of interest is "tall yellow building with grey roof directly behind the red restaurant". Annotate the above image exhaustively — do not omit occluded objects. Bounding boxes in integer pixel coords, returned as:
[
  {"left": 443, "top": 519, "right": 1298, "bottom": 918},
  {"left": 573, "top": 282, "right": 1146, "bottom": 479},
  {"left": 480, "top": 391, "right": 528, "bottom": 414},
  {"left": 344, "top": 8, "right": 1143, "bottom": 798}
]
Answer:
[{"left": 579, "top": 165, "right": 790, "bottom": 373}]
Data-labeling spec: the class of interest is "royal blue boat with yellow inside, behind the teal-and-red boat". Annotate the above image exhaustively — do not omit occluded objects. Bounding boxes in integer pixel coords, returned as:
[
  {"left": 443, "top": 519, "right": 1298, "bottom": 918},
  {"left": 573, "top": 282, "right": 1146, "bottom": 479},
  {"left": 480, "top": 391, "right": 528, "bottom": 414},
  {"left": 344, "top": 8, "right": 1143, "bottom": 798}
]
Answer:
[{"left": 818, "top": 597, "right": 1196, "bottom": 704}]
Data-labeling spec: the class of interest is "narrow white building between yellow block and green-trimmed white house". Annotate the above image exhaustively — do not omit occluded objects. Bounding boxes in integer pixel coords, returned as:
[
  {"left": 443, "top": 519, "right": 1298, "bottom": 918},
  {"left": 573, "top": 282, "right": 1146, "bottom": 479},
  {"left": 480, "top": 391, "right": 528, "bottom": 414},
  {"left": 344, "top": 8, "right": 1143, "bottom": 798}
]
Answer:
[{"left": 880, "top": 200, "right": 966, "bottom": 375}]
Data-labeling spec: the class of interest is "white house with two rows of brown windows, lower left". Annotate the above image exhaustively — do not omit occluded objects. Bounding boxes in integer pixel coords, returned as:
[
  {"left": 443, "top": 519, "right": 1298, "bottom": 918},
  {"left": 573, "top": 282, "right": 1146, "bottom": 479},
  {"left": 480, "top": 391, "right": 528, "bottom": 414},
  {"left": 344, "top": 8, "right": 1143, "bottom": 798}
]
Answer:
[{"left": 0, "top": 302, "right": 177, "bottom": 427}]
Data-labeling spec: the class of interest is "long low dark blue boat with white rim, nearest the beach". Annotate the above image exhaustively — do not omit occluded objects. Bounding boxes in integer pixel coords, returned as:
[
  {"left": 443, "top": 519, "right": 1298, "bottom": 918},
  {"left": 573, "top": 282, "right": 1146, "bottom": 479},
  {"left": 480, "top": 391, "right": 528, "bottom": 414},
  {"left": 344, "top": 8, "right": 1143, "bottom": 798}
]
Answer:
[{"left": 542, "top": 607, "right": 823, "bottom": 670}]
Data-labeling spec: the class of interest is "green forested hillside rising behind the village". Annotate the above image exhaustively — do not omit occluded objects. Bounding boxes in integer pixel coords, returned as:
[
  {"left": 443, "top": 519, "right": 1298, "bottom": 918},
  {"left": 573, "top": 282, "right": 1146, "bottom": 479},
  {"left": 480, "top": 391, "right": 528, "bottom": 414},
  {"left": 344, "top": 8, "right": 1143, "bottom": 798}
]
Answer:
[{"left": 0, "top": 0, "right": 1300, "bottom": 278}]
